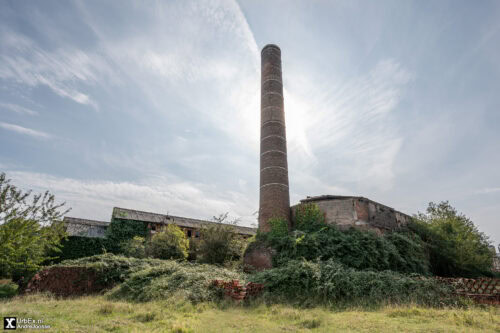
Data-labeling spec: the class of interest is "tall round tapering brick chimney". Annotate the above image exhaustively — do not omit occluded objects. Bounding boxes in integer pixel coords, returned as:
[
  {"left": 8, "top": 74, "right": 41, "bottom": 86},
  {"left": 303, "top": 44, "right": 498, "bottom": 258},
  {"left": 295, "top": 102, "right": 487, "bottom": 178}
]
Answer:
[{"left": 259, "top": 44, "right": 290, "bottom": 232}]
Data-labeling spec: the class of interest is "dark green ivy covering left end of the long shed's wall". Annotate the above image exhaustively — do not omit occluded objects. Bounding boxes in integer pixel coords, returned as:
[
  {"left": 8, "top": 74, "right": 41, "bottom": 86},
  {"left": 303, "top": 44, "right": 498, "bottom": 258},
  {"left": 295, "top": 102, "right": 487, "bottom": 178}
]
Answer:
[{"left": 106, "top": 218, "right": 148, "bottom": 254}]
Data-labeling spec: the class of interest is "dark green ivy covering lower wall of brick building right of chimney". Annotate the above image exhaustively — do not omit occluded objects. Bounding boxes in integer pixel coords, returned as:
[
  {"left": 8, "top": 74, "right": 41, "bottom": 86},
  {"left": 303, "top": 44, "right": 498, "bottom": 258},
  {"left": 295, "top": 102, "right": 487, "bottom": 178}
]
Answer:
[{"left": 258, "top": 204, "right": 428, "bottom": 275}]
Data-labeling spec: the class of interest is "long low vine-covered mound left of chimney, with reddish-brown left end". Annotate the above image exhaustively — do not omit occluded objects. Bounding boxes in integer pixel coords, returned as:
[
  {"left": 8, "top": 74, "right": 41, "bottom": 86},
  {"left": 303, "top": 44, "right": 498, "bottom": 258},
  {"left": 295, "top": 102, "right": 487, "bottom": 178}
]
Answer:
[{"left": 25, "top": 254, "right": 245, "bottom": 302}]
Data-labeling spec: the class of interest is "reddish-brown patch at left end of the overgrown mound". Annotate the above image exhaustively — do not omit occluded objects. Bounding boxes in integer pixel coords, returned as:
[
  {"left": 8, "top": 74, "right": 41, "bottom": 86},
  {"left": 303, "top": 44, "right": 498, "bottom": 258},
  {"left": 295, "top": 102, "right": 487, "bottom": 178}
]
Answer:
[{"left": 24, "top": 266, "right": 111, "bottom": 296}]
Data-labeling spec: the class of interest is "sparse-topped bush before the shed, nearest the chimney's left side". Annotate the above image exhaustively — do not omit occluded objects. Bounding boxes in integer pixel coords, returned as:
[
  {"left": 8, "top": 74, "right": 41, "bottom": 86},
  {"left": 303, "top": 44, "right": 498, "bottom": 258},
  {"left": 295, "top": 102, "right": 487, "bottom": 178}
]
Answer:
[{"left": 197, "top": 213, "right": 247, "bottom": 265}]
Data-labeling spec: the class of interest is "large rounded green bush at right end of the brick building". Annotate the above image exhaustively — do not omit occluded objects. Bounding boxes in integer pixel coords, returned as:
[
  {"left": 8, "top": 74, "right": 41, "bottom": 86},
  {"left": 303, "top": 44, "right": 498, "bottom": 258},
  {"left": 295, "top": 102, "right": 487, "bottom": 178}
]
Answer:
[{"left": 410, "top": 201, "right": 492, "bottom": 277}]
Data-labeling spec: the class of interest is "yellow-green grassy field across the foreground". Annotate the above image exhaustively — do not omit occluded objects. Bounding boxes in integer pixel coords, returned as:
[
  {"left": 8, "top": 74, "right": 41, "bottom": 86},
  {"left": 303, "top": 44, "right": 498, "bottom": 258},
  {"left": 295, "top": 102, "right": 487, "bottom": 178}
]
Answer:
[{"left": 0, "top": 294, "right": 500, "bottom": 332}]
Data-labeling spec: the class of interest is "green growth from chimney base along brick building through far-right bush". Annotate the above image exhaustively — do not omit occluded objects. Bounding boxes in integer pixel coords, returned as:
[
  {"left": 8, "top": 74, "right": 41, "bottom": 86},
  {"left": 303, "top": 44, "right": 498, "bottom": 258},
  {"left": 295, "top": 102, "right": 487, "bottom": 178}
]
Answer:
[{"left": 257, "top": 202, "right": 493, "bottom": 277}]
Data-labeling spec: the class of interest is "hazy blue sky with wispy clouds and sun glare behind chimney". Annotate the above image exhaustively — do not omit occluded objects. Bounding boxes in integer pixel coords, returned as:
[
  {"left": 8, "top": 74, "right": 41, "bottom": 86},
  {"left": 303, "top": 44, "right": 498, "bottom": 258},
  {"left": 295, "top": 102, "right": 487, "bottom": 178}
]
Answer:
[{"left": 0, "top": 0, "right": 500, "bottom": 245}]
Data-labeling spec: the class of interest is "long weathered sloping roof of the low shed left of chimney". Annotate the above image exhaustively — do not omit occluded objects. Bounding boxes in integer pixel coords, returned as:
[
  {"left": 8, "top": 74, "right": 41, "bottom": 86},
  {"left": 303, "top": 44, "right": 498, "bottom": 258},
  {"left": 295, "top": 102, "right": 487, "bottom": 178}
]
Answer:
[{"left": 113, "top": 207, "right": 257, "bottom": 235}]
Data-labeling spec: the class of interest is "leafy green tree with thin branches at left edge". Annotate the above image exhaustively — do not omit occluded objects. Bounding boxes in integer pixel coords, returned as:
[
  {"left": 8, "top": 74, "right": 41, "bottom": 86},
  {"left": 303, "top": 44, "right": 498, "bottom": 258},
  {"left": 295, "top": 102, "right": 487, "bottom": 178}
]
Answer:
[{"left": 0, "top": 173, "right": 69, "bottom": 281}]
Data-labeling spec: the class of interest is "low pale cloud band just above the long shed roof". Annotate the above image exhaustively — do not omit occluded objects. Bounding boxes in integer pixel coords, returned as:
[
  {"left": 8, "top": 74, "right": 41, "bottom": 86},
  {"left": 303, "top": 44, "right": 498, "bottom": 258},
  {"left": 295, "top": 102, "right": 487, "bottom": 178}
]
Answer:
[{"left": 7, "top": 171, "right": 256, "bottom": 225}]
